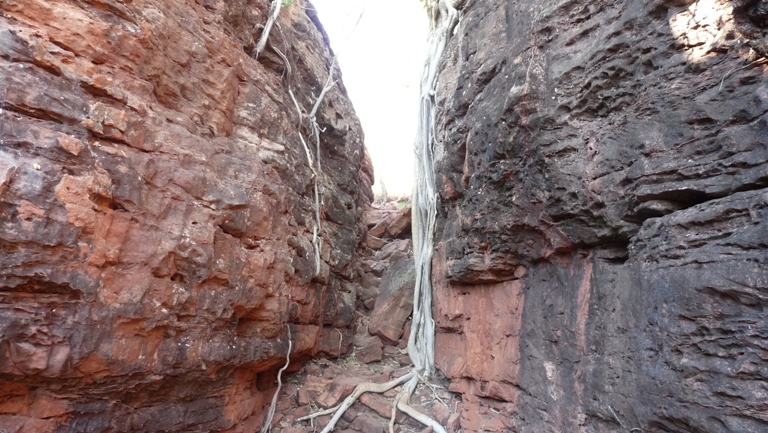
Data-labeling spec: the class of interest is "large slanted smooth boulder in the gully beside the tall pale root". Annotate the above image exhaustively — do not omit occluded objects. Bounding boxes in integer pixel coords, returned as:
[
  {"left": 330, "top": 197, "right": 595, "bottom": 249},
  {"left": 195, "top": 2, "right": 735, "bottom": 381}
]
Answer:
[{"left": 368, "top": 251, "right": 416, "bottom": 344}]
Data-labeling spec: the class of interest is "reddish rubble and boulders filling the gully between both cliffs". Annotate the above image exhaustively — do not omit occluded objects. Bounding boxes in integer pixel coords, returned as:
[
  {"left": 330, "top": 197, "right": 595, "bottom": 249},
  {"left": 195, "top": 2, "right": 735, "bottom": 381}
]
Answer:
[{"left": 264, "top": 200, "right": 461, "bottom": 433}]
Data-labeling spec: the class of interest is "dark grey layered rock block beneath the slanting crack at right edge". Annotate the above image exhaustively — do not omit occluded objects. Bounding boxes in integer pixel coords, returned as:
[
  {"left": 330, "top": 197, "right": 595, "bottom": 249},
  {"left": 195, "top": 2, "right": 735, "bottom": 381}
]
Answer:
[{"left": 630, "top": 189, "right": 768, "bottom": 432}]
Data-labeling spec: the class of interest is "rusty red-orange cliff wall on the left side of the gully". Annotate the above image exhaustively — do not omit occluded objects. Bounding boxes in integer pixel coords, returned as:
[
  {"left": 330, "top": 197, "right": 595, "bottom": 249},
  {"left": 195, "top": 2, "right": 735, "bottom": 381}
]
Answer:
[{"left": 0, "top": 0, "right": 372, "bottom": 432}]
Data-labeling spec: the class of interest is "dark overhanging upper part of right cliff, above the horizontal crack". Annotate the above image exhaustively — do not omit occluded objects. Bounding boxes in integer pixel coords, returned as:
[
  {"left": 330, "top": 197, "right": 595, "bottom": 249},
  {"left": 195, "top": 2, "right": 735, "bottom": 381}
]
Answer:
[{"left": 437, "top": 0, "right": 768, "bottom": 283}]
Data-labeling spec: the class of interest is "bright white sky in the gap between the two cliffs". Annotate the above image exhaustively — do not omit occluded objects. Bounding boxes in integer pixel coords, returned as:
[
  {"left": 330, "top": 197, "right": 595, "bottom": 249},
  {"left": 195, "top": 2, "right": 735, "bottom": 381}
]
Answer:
[{"left": 311, "top": 0, "right": 428, "bottom": 197}]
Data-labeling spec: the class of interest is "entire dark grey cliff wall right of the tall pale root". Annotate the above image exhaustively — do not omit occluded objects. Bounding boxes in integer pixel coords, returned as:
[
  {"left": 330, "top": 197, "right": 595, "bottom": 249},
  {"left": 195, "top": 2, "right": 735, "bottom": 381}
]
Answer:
[{"left": 433, "top": 0, "right": 768, "bottom": 433}]
